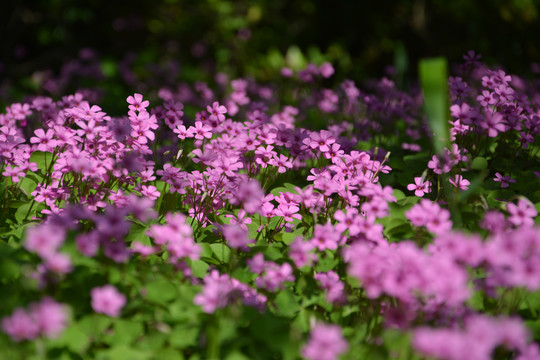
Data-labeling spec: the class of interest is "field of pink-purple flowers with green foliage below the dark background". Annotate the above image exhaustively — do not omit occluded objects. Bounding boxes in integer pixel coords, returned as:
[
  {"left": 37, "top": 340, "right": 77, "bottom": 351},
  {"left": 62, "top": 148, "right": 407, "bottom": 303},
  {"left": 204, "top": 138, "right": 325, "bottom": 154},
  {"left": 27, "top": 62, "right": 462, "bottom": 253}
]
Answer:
[{"left": 0, "top": 52, "right": 540, "bottom": 360}]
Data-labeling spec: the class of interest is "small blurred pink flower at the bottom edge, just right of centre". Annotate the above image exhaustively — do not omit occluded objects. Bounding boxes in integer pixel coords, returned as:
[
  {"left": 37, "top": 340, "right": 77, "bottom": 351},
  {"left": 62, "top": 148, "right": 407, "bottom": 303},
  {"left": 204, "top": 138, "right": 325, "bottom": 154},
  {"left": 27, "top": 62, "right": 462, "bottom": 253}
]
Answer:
[{"left": 302, "top": 324, "right": 349, "bottom": 360}]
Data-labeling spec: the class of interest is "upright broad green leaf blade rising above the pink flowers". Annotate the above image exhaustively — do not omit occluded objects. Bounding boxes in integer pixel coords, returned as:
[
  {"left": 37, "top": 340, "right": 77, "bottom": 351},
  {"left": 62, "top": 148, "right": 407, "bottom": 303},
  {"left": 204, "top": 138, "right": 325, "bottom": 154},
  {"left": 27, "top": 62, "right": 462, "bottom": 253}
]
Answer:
[{"left": 419, "top": 58, "right": 450, "bottom": 153}]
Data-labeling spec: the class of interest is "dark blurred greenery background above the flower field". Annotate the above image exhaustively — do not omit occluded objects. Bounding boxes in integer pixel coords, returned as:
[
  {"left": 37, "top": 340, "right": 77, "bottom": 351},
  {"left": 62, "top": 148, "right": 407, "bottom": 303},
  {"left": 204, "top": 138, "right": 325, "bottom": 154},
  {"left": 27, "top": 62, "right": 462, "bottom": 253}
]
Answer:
[{"left": 0, "top": 0, "right": 540, "bottom": 111}]
